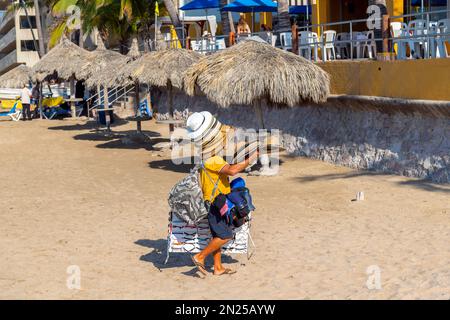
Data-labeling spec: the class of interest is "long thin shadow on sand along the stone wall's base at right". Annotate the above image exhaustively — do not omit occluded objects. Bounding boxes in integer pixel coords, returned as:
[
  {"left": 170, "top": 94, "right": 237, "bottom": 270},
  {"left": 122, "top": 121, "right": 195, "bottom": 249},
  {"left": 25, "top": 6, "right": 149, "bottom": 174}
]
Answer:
[{"left": 295, "top": 170, "right": 450, "bottom": 193}]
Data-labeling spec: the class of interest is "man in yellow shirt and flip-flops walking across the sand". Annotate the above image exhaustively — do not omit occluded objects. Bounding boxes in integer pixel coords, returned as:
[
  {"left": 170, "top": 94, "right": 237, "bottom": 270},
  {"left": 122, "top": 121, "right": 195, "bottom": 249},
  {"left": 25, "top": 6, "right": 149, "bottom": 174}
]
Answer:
[{"left": 186, "top": 112, "right": 258, "bottom": 275}]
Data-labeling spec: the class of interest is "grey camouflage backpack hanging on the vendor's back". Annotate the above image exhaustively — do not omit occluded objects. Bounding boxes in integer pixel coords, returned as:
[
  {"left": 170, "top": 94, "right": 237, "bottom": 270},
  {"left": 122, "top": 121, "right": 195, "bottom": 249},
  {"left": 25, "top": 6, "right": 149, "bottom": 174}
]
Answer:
[{"left": 168, "top": 165, "right": 216, "bottom": 224}]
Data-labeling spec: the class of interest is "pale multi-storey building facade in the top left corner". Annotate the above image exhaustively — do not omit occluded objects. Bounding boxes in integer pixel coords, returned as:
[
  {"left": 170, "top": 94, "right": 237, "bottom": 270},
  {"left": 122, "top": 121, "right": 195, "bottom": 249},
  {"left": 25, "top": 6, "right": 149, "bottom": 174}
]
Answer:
[{"left": 0, "top": 1, "right": 39, "bottom": 74}]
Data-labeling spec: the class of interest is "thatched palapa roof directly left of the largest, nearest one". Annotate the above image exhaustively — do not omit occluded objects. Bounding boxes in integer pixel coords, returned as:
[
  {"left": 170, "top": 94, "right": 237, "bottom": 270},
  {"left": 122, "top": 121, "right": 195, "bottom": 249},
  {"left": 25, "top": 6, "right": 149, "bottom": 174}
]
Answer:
[{"left": 120, "top": 49, "right": 201, "bottom": 89}]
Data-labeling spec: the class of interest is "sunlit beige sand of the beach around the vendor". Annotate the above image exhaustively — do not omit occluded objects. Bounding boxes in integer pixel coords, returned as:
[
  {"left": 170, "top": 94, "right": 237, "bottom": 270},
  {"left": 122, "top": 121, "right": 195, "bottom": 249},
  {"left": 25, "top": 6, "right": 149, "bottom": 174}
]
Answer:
[{"left": 0, "top": 121, "right": 450, "bottom": 299}]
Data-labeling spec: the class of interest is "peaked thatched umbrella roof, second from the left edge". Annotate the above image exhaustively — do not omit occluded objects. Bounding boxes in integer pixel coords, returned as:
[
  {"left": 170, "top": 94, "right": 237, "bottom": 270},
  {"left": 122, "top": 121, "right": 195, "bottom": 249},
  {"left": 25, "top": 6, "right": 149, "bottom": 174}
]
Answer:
[{"left": 31, "top": 37, "right": 90, "bottom": 81}]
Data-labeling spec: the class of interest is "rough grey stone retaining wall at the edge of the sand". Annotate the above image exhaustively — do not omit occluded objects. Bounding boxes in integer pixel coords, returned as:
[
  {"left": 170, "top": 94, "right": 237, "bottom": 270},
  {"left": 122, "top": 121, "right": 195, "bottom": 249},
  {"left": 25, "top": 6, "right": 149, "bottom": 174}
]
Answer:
[{"left": 155, "top": 92, "right": 450, "bottom": 183}]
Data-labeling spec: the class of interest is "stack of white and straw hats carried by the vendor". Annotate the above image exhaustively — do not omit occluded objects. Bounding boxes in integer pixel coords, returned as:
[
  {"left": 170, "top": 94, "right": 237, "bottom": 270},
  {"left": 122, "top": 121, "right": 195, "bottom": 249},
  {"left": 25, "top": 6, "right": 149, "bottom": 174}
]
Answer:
[{"left": 186, "top": 111, "right": 273, "bottom": 163}]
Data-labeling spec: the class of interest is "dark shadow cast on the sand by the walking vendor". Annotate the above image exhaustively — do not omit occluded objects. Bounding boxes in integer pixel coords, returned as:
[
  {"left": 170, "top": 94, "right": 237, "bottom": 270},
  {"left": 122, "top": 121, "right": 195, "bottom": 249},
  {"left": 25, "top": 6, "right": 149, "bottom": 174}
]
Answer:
[{"left": 135, "top": 239, "right": 238, "bottom": 276}]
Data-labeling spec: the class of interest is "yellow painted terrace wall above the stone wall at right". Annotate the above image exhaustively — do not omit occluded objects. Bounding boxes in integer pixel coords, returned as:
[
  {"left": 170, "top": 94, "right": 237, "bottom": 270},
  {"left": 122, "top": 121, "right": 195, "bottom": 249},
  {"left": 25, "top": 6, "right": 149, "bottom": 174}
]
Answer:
[{"left": 318, "top": 59, "right": 450, "bottom": 101}]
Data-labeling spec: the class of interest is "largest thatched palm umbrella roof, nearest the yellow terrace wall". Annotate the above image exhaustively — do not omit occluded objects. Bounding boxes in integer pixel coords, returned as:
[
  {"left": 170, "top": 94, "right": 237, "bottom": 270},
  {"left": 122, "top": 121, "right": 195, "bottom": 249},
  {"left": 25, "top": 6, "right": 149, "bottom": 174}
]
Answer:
[{"left": 184, "top": 40, "right": 330, "bottom": 107}]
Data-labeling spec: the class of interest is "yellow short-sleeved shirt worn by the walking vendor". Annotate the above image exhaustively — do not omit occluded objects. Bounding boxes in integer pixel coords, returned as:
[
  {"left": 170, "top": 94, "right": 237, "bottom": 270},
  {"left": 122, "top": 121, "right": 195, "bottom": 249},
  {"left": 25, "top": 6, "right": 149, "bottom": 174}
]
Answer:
[{"left": 200, "top": 156, "right": 231, "bottom": 202}]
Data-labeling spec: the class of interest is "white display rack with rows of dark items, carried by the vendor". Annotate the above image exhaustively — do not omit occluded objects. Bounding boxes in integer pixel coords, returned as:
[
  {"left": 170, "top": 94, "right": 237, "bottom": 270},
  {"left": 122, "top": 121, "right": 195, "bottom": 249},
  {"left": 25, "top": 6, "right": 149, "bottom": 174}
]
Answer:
[{"left": 164, "top": 212, "right": 256, "bottom": 264}]
